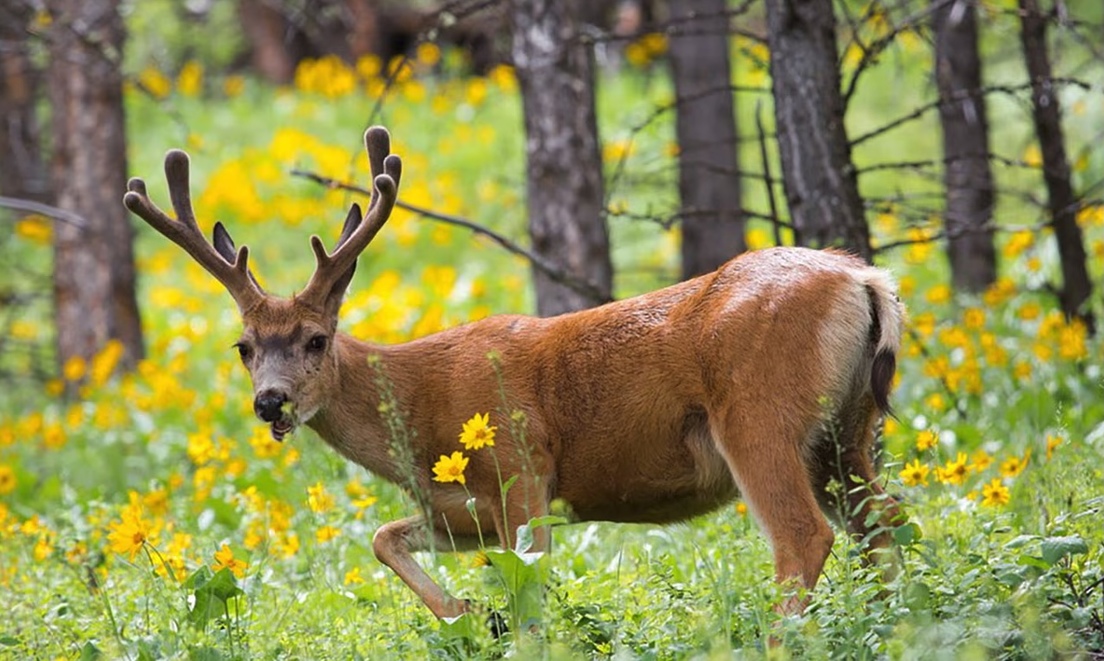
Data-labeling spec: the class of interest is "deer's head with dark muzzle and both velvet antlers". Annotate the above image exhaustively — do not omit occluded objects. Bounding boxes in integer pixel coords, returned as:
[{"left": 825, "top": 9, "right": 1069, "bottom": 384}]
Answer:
[{"left": 123, "top": 127, "right": 402, "bottom": 440}]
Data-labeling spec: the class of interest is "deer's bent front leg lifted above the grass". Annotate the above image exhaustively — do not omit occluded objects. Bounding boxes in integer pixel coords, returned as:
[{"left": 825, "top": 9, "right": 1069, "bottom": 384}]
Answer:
[{"left": 372, "top": 516, "right": 479, "bottom": 619}]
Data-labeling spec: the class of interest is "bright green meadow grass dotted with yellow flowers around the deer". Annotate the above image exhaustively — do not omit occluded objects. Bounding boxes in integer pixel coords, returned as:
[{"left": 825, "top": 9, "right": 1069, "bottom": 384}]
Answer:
[{"left": 0, "top": 14, "right": 1104, "bottom": 659}]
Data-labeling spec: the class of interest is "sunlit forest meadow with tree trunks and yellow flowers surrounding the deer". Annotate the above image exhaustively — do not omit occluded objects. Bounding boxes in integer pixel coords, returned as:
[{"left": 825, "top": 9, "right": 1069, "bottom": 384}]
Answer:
[{"left": 0, "top": 0, "right": 1104, "bottom": 659}]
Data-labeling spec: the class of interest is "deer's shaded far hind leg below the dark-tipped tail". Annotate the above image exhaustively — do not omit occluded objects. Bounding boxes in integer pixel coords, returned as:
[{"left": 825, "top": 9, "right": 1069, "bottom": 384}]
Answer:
[{"left": 809, "top": 395, "right": 902, "bottom": 562}]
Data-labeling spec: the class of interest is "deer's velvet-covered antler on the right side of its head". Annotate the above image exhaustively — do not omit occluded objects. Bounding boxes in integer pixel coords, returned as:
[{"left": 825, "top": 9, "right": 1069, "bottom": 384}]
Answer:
[{"left": 297, "top": 126, "right": 403, "bottom": 307}]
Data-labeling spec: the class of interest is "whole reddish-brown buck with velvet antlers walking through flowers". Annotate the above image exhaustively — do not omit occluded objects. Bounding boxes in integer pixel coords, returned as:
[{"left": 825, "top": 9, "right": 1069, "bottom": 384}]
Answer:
[{"left": 124, "top": 127, "right": 904, "bottom": 618}]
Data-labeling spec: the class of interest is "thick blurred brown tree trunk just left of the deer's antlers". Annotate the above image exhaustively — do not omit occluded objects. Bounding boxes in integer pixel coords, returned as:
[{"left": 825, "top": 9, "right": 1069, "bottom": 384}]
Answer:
[{"left": 47, "top": 0, "right": 142, "bottom": 381}]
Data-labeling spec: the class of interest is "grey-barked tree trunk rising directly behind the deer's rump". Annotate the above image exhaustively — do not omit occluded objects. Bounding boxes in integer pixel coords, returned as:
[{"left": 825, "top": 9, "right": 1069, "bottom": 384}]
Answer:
[{"left": 766, "top": 0, "right": 871, "bottom": 262}]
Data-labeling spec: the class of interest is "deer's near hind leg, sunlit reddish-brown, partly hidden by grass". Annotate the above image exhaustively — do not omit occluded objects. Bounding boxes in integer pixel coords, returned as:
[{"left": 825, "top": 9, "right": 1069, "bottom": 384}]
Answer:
[{"left": 713, "top": 412, "right": 835, "bottom": 614}]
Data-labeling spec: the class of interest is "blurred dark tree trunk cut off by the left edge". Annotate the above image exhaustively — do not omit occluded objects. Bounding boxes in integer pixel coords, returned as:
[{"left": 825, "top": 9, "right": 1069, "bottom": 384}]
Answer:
[{"left": 0, "top": 2, "right": 53, "bottom": 203}]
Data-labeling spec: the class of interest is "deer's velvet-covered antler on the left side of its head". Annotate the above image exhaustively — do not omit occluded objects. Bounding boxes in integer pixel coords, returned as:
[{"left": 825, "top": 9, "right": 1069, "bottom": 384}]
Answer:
[{"left": 123, "top": 149, "right": 265, "bottom": 313}]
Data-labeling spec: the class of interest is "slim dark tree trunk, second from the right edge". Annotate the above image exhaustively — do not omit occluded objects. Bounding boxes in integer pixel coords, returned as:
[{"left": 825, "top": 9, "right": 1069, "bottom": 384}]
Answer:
[{"left": 932, "top": 0, "right": 997, "bottom": 292}]
